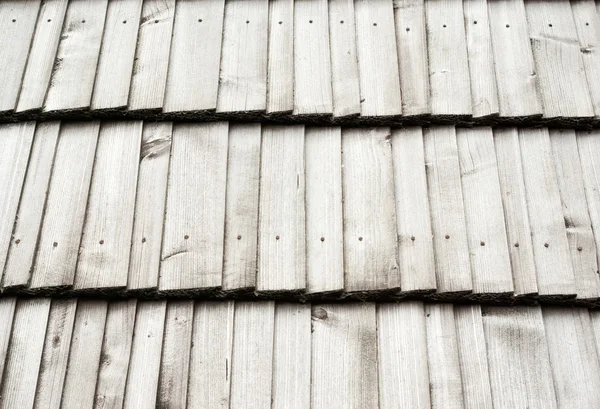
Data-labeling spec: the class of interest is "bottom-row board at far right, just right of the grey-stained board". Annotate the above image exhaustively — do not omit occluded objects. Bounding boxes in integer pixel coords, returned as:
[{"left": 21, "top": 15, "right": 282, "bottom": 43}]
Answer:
[{"left": 543, "top": 307, "right": 600, "bottom": 409}]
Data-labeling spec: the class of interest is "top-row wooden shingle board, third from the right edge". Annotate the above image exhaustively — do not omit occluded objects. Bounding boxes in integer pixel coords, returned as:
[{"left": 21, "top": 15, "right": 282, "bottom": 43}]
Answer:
[{"left": 487, "top": 0, "right": 543, "bottom": 117}]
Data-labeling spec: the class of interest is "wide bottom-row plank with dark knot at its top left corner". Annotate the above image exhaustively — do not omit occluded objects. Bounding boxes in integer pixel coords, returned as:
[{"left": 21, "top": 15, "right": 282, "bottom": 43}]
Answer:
[{"left": 311, "top": 303, "right": 379, "bottom": 409}]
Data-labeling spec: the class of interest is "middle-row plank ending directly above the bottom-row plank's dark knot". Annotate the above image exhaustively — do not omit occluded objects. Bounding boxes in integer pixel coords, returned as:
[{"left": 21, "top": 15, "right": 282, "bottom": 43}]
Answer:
[{"left": 305, "top": 127, "right": 344, "bottom": 294}]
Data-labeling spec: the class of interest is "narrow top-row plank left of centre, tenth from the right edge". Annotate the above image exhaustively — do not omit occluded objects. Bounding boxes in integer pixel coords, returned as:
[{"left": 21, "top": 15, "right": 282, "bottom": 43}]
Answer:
[{"left": 267, "top": 0, "right": 294, "bottom": 113}]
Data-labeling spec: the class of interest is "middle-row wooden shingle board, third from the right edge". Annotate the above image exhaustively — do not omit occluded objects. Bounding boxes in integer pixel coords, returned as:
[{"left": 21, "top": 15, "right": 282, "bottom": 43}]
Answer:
[{"left": 519, "top": 128, "right": 576, "bottom": 297}]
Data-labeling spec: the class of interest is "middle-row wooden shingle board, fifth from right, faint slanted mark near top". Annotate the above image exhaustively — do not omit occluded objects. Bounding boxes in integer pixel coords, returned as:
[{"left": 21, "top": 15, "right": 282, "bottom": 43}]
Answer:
[{"left": 456, "top": 127, "right": 514, "bottom": 297}]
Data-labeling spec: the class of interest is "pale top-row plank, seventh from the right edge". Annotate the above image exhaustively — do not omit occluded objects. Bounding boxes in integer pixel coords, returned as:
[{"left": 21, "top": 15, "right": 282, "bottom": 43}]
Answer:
[{"left": 354, "top": 0, "right": 402, "bottom": 116}]
